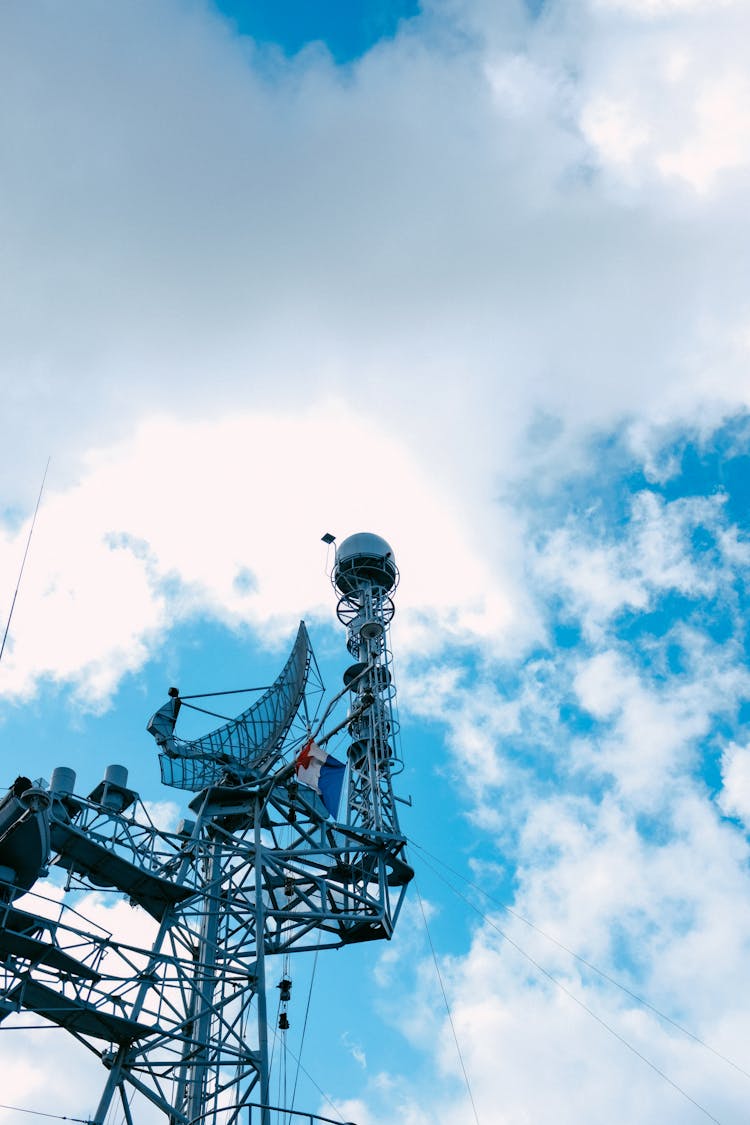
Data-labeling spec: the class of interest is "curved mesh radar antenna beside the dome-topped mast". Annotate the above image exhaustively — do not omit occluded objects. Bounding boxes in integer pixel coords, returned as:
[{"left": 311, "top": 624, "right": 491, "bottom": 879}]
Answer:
[{"left": 147, "top": 621, "right": 311, "bottom": 793}]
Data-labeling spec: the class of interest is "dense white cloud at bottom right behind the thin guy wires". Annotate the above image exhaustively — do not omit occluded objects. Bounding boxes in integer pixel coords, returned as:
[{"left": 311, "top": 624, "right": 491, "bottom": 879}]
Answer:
[{"left": 369, "top": 778, "right": 750, "bottom": 1125}]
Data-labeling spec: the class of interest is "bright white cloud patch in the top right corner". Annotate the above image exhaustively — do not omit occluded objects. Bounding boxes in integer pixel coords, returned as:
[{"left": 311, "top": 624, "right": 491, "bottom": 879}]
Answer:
[{"left": 580, "top": 0, "right": 750, "bottom": 196}]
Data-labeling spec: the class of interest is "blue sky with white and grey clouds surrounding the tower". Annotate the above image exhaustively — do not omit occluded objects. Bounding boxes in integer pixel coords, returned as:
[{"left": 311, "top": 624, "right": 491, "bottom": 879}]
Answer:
[{"left": 0, "top": 0, "right": 750, "bottom": 1125}]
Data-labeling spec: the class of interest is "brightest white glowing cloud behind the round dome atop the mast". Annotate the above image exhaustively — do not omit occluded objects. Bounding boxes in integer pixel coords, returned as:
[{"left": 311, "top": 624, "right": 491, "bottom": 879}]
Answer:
[{"left": 2, "top": 403, "right": 527, "bottom": 705}]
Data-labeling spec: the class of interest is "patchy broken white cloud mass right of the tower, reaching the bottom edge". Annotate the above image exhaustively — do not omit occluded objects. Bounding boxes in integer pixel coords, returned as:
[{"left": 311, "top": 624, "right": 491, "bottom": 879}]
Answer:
[{"left": 384, "top": 454, "right": 750, "bottom": 1125}]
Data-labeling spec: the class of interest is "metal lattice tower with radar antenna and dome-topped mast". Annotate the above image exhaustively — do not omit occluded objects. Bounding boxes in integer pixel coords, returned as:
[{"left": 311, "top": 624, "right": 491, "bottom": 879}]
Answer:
[{"left": 0, "top": 533, "right": 413, "bottom": 1125}]
